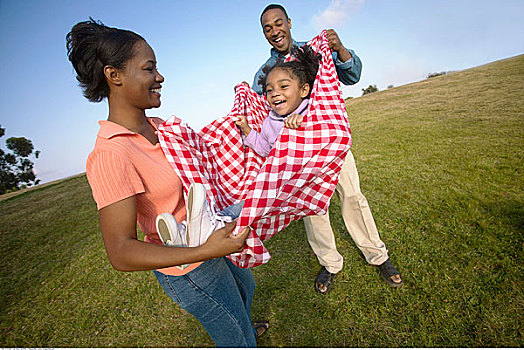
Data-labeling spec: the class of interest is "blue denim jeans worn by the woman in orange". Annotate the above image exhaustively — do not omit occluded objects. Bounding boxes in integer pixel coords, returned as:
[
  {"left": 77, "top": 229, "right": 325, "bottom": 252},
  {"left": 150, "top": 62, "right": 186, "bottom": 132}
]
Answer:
[{"left": 154, "top": 257, "right": 256, "bottom": 347}]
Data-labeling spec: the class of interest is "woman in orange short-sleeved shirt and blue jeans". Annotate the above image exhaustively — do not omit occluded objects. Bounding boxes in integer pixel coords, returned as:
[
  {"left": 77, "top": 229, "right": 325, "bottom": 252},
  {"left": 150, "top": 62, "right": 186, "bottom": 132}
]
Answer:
[{"left": 67, "top": 19, "right": 268, "bottom": 347}]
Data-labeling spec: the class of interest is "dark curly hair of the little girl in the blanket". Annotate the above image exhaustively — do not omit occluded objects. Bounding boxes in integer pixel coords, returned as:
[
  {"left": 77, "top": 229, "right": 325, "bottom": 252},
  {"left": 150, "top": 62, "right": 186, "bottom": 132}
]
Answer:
[{"left": 258, "top": 44, "right": 322, "bottom": 98}]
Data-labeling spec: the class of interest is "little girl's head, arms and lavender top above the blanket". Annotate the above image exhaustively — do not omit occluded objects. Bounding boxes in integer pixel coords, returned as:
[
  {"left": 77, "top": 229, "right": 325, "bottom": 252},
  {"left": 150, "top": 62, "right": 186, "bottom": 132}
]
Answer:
[{"left": 236, "top": 45, "right": 321, "bottom": 157}]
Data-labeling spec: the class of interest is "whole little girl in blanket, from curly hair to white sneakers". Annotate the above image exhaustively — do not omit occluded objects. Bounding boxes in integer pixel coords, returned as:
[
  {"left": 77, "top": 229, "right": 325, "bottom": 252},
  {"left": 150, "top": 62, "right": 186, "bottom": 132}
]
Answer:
[{"left": 156, "top": 45, "right": 321, "bottom": 253}]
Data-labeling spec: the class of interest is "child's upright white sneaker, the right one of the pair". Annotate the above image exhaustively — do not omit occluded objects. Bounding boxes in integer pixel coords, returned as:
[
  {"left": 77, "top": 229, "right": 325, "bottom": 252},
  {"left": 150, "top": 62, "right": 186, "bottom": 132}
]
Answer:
[{"left": 186, "top": 183, "right": 224, "bottom": 247}]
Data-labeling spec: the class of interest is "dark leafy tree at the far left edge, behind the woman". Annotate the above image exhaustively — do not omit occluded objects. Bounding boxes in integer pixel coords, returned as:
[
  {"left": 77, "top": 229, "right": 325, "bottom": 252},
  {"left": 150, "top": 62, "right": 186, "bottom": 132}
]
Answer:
[{"left": 0, "top": 126, "right": 40, "bottom": 194}]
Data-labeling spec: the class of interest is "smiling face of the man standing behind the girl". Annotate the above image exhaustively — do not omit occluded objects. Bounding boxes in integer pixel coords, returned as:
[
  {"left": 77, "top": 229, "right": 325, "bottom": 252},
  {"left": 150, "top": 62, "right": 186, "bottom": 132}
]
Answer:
[{"left": 262, "top": 9, "right": 293, "bottom": 55}]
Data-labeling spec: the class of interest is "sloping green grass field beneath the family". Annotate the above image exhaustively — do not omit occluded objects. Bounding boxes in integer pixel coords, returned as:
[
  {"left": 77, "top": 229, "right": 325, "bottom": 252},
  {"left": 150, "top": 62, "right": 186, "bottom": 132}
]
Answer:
[{"left": 0, "top": 55, "right": 524, "bottom": 347}]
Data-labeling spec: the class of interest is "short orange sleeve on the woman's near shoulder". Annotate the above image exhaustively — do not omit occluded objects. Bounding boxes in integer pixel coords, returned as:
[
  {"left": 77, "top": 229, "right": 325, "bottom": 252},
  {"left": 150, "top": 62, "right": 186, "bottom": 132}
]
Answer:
[{"left": 86, "top": 151, "right": 145, "bottom": 210}]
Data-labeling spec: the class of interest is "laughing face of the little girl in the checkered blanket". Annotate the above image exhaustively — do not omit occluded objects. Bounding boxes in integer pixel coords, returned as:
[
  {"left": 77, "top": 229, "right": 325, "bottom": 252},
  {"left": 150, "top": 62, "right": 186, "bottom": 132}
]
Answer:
[{"left": 266, "top": 68, "right": 309, "bottom": 116}]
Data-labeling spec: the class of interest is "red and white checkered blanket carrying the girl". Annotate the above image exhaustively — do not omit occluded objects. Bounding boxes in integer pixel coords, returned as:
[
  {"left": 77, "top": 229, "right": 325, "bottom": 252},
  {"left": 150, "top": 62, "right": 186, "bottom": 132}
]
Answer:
[{"left": 158, "top": 31, "right": 351, "bottom": 268}]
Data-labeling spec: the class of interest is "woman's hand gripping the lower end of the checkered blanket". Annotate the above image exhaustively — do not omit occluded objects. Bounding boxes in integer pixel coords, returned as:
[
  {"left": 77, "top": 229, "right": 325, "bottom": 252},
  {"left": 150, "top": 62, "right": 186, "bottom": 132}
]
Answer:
[{"left": 200, "top": 221, "right": 250, "bottom": 259}]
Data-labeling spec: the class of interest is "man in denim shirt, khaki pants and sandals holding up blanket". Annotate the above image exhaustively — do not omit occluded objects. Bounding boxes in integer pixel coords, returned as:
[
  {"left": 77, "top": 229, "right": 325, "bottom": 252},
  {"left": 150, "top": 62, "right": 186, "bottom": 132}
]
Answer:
[{"left": 252, "top": 4, "right": 403, "bottom": 294}]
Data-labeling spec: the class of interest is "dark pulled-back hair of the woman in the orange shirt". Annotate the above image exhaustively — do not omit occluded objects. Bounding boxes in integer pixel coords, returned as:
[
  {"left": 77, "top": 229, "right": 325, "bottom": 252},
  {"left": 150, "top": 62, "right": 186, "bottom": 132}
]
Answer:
[{"left": 66, "top": 17, "right": 145, "bottom": 102}]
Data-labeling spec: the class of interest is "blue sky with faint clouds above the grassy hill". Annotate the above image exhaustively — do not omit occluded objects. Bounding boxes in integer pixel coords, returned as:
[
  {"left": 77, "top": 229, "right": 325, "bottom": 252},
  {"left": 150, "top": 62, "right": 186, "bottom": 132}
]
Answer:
[{"left": 0, "top": 0, "right": 524, "bottom": 183}]
